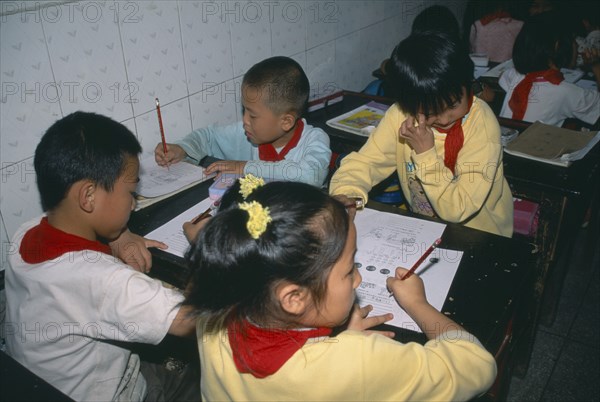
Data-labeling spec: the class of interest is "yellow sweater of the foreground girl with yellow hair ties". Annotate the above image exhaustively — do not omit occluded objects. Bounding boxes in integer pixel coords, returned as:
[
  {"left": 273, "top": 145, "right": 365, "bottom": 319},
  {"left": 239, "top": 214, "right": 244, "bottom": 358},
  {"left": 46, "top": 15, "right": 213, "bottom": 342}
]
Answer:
[{"left": 198, "top": 328, "right": 496, "bottom": 402}]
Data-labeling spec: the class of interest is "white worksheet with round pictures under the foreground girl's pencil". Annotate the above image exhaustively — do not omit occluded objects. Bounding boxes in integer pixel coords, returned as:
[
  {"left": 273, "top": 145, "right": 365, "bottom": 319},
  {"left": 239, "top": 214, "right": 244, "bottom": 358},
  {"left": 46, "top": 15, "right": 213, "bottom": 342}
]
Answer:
[{"left": 354, "top": 208, "right": 462, "bottom": 332}]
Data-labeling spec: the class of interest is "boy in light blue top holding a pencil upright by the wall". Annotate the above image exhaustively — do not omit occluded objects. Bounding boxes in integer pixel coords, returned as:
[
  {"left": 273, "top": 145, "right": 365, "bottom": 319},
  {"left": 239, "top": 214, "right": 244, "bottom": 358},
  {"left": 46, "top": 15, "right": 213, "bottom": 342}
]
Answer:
[{"left": 154, "top": 56, "right": 331, "bottom": 186}]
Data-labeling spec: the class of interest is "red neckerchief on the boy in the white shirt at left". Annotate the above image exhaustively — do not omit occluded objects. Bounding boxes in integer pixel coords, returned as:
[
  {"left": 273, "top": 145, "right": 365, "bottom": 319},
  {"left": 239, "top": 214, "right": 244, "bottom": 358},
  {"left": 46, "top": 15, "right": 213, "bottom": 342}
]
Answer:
[{"left": 19, "top": 216, "right": 112, "bottom": 264}]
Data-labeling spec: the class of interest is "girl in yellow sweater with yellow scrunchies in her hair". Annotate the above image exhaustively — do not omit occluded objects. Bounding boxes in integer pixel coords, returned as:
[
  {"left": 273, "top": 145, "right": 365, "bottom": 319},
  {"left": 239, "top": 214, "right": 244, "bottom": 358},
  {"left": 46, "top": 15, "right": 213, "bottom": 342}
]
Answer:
[{"left": 186, "top": 180, "right": 496, "bottom": 401}]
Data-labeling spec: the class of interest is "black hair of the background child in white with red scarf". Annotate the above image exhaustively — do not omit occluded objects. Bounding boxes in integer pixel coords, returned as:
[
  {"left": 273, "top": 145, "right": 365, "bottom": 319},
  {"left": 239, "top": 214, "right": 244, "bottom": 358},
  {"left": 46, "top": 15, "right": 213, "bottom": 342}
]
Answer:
[{"left": 513, "top": 11, "right": 575, "bottom": 74}]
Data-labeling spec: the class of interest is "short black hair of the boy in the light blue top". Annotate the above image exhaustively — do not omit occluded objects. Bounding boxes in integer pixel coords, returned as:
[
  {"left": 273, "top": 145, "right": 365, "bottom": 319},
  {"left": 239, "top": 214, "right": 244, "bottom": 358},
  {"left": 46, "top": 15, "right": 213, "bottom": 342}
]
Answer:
[{"left": 242, "top": 56, "right": 310, "bottom": 118}]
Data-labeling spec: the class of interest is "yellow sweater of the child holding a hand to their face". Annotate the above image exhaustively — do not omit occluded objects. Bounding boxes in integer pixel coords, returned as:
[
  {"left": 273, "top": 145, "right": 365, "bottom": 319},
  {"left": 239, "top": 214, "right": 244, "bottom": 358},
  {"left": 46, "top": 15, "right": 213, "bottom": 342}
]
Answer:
[{"left": 330, "top": 98, "right": 513, "bottom": 237}]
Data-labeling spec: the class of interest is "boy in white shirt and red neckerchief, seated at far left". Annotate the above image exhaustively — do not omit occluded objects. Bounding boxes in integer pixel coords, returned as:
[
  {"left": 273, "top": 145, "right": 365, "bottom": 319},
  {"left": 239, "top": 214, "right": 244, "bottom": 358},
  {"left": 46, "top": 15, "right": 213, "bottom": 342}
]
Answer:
[{"left": 6, "top": 112, "right": 199, "bottom": 401}]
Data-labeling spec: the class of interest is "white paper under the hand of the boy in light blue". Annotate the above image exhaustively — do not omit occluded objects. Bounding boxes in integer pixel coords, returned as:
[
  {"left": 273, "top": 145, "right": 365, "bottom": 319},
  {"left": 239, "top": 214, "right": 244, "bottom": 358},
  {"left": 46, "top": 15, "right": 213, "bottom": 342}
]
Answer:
[{"left": 137, "top": 154, "right": 210, "bottom": 198}]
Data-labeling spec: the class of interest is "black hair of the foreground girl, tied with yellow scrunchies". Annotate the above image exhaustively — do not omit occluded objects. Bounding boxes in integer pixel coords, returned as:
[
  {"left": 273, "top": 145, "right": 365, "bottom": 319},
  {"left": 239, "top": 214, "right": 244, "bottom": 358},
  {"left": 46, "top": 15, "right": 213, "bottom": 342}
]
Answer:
[{"left": 185, "top": 182, "right": 350, "bottom": 330}]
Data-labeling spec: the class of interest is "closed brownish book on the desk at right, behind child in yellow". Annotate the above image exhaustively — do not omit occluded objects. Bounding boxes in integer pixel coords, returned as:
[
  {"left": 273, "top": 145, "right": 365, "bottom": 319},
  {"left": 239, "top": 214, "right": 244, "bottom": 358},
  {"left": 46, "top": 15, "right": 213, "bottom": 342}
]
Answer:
[{"left": 504, "top": 121, "right": 600, "bottom": 167}]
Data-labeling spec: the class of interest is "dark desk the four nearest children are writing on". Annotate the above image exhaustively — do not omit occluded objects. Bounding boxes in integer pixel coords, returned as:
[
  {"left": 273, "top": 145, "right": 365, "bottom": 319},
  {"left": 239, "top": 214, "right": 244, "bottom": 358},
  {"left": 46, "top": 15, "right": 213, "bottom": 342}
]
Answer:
[{"left": 129, "top": 177, "right": 535, "bottom": 399}]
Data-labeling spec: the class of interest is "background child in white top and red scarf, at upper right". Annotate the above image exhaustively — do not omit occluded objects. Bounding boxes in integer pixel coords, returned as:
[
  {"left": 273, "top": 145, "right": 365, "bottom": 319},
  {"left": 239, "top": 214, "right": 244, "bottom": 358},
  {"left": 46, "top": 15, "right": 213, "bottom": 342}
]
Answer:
[{"left": 499, "top": 12, "right": 600, "bottom": 126}]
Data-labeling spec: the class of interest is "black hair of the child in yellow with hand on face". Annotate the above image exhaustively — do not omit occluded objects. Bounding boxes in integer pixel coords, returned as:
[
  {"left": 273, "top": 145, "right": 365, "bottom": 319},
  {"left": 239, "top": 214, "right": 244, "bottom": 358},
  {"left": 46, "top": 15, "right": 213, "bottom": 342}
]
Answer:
[{"left": 387, "top": 32, "right": 474, "bottom": 116}]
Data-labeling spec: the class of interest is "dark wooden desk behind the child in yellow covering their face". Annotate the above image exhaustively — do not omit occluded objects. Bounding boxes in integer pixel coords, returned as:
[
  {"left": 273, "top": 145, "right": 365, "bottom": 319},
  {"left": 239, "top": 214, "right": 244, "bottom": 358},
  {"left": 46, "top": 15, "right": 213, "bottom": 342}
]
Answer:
[{"left": 307, "top": 91, "right": 600, "bottom": 376}]
